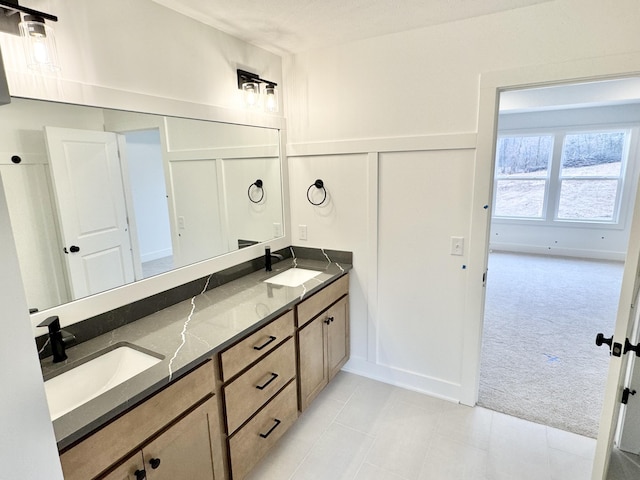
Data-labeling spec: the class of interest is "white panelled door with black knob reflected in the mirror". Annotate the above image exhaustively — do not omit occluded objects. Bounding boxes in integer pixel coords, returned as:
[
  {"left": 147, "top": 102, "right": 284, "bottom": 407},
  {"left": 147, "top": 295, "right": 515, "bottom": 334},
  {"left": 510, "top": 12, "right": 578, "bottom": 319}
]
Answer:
[{"left": 44, "top": 127, "right": 134, "bottom": 298}]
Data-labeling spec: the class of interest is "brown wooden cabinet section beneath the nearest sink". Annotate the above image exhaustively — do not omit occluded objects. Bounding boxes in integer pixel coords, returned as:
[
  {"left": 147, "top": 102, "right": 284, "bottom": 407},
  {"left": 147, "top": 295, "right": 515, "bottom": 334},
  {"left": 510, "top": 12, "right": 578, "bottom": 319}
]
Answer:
[{"left": 60, "top": 361, "right": 224, "bottom": 480}]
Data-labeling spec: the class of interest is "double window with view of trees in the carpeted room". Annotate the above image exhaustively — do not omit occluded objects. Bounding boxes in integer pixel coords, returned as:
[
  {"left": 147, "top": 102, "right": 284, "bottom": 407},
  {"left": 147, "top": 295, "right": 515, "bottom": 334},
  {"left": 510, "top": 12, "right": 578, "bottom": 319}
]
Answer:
[{"left": 493, "top": 130, "right": 629, "bottom": 223}]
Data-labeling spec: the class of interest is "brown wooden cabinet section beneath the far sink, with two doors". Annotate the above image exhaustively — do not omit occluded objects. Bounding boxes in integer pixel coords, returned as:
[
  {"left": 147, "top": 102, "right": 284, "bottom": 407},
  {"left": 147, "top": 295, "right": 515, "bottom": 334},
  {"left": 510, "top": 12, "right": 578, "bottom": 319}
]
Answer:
[{"left": 297, "top": 276, "right": 349, "bottom": 411}]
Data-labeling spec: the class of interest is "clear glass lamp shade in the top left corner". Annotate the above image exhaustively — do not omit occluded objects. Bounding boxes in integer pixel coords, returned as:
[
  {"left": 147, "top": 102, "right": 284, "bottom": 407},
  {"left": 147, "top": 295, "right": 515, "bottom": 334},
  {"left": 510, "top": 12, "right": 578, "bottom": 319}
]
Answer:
[{"left": 20, "top": 15, "right": 60, "bottom": 72}]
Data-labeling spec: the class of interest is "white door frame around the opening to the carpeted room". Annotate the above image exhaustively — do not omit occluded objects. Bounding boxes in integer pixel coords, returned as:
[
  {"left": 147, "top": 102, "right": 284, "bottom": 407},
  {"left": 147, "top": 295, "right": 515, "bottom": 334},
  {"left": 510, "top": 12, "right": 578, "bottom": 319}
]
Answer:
[{"left": 460, "top": 54, "right": 640, "bottom": 479}]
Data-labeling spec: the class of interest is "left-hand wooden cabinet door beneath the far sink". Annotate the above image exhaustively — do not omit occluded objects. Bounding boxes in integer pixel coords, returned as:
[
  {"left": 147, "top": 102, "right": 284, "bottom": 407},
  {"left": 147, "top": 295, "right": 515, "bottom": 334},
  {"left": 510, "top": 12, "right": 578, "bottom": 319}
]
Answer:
[{"left": 298, "top": 315, "right": 329, "bottom": 411}]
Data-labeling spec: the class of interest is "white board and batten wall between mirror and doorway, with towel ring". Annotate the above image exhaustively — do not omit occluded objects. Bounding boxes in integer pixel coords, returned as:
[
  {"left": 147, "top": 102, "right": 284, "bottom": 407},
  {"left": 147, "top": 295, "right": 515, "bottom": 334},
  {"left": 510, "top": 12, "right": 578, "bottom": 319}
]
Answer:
[{"left": 283, "top": 0, "right": 640, "bottom": 405}]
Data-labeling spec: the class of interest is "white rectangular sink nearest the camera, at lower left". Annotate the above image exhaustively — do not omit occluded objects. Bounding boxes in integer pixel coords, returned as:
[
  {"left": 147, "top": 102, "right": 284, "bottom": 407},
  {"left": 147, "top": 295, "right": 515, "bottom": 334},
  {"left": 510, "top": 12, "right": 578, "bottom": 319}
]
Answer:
[{"left": 44, "top": 345, "right": 161, "bottom": 420}]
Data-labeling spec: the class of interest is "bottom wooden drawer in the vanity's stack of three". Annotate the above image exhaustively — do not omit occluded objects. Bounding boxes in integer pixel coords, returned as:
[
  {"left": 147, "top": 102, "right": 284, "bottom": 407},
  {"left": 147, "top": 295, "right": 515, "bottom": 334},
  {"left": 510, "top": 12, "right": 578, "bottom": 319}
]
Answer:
[{"left": 229, "top": 380, "right": 298, "bottom": 480}]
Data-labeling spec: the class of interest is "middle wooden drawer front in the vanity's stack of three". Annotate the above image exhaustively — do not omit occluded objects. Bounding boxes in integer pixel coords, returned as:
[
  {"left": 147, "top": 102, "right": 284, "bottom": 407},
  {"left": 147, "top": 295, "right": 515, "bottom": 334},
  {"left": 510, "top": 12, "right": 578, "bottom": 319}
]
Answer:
[{"left": 224, "top": 338, "right": 296, "bottom": 433}]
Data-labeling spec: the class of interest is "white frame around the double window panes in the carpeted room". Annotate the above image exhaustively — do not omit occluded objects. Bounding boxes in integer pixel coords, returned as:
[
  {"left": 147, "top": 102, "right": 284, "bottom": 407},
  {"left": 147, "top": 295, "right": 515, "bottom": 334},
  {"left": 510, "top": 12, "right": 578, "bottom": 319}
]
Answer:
[{"left": 491, "top": 123, "right": 640, "bottom": 230}]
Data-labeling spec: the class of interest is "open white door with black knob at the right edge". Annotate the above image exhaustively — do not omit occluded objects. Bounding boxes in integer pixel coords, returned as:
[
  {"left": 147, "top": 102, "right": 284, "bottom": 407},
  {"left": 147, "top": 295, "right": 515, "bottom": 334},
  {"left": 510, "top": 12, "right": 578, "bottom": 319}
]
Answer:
[{"left": 592, "top": 182, "right": 640, "bottom": 480}]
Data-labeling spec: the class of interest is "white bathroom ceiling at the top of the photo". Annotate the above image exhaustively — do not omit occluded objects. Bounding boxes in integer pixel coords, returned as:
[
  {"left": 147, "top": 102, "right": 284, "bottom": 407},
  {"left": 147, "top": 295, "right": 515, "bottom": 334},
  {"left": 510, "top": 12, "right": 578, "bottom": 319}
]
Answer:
[{"left": 153, "top": 0, "right": 552, "bottom": 55}]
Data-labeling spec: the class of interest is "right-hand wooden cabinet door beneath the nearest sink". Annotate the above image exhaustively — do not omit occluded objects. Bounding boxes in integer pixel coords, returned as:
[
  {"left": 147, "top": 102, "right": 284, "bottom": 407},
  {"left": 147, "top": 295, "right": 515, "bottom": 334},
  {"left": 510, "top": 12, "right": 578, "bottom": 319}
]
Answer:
[{"left": 142, "top": 399, "right": 222, "bottom": 480}]
